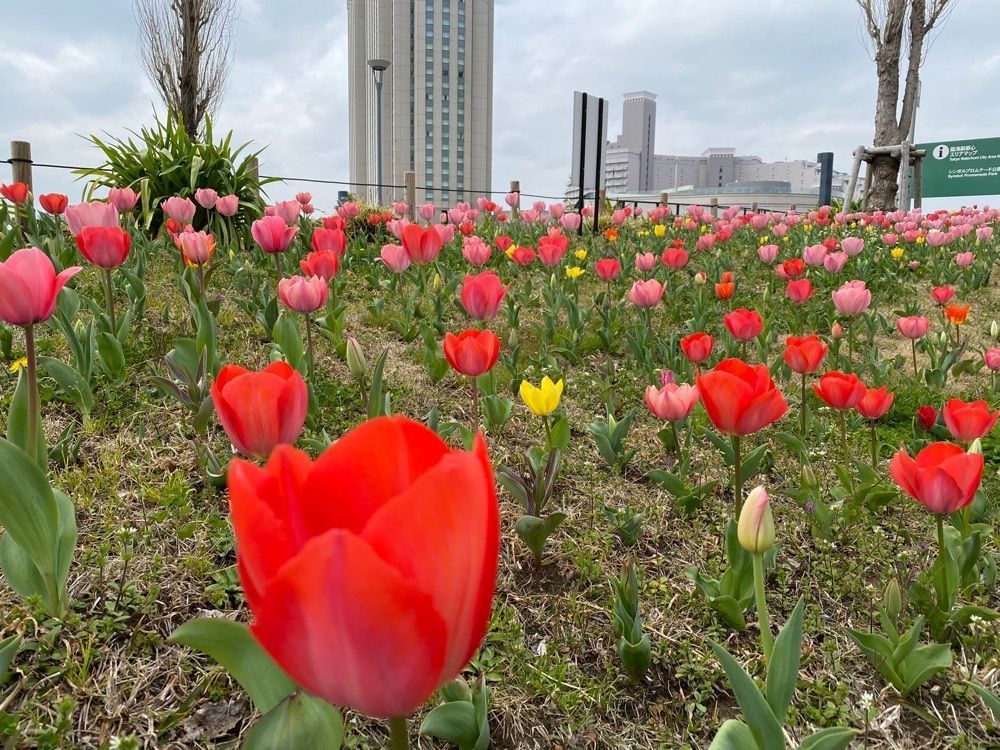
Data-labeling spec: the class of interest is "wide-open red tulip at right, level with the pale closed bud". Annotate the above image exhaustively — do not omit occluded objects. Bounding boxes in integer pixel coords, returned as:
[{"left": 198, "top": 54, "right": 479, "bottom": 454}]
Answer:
[{"left": 889, "top": 442, "right": 983, "bottom": 514}]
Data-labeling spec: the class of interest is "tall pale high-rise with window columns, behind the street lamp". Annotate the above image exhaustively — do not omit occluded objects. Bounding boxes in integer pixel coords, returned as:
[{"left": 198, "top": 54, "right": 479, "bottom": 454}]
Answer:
[{"left": 347, "top": 0, "right": 493, "bottom": 204}]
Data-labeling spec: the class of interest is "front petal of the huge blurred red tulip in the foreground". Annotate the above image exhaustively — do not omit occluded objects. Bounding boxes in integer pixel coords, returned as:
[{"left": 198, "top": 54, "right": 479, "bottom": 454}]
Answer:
[{"left": 250, "top": 529, "right": 447, "bottom": 718}]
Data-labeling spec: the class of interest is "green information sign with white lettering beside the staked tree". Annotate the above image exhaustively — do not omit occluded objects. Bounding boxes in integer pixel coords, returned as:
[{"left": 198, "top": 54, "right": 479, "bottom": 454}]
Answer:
[{"left": 917, "top": 138, "right": 1000, "bottom": 198}]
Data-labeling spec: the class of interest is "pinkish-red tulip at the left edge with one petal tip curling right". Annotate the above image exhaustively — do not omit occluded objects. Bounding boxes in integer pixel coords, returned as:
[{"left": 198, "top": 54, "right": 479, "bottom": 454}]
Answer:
[{"left": 0, "top": 247, "right": 82, "bottom": 326}]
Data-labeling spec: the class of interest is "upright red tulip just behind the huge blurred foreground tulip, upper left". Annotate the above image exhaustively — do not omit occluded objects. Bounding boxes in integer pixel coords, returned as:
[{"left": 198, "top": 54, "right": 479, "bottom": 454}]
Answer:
[{"left": 212, "top": 361, "right": 309, "bottom": 459}]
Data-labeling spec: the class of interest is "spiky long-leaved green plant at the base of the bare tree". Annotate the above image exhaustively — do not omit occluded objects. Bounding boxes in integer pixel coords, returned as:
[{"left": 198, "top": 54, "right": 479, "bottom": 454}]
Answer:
[{"left": 76, "top": 111, "right": 277, "bottom": 233}]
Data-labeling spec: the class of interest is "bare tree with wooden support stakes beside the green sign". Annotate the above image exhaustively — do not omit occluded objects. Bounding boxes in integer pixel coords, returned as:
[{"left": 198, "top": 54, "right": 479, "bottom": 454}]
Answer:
[{"left": 857, "top": 0, "right": 958, "bottom": 210}]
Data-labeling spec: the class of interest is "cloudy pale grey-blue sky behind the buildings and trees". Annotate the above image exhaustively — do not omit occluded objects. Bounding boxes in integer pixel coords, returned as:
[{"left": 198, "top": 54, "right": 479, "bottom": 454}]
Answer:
[{"left": 0, "top": 0, "right": 1000, "bottom": 208}]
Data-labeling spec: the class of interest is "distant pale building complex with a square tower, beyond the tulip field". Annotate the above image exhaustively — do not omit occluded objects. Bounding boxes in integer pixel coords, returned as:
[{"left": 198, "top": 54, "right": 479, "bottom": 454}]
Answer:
[{"left": 566, "top": 91, "right": 848, "bottom": 197}]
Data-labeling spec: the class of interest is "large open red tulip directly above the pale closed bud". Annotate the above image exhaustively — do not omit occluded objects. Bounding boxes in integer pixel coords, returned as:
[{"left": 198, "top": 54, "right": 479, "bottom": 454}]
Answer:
[{"left": 697, "top": 358, "right": 788, "bottom": 435}]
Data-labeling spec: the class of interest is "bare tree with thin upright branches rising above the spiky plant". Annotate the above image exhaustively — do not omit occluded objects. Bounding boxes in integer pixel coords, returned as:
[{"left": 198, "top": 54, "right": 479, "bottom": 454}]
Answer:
[{"left": 135, "top": 0, "right": 239, "bottom": 140}]
